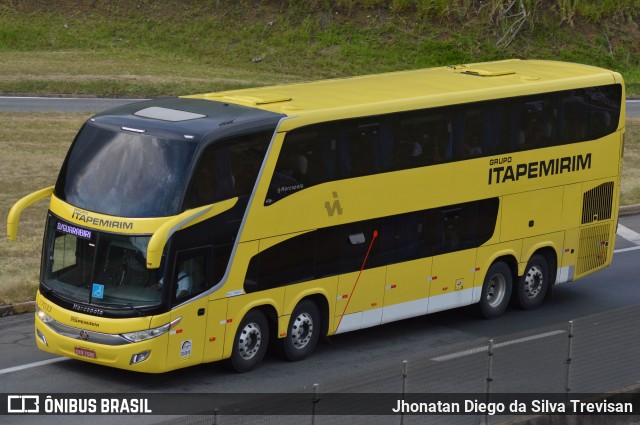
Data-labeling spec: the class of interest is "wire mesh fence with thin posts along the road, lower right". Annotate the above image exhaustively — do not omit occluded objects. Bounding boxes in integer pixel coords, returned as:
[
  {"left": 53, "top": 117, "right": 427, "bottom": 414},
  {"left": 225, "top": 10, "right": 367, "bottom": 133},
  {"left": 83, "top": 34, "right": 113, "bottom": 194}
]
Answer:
[{"left": 155, "top": 306, "right": 640, "bottom": 425}]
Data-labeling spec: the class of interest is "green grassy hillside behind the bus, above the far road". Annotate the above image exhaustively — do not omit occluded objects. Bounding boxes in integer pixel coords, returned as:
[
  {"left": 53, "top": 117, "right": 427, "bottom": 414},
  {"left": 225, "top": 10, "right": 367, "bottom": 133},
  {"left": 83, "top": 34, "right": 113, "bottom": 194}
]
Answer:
[{"left": 0, "top": 0, "right": 640, "bottom": 96}]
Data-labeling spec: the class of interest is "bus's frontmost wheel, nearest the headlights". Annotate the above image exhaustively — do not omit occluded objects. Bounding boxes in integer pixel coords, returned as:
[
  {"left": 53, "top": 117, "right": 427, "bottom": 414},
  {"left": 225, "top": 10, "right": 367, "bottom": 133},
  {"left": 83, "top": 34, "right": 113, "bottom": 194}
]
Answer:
[{"left": 231, "top": 310, "right": 269, "bottom": 373}]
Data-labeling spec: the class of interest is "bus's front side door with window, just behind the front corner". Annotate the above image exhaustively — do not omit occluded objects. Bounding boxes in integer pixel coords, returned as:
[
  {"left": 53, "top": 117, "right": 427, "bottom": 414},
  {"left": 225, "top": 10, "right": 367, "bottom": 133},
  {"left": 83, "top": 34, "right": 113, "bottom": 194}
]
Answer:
[{"left": 167, "top": 248, "right": 211, "bottom": 369}]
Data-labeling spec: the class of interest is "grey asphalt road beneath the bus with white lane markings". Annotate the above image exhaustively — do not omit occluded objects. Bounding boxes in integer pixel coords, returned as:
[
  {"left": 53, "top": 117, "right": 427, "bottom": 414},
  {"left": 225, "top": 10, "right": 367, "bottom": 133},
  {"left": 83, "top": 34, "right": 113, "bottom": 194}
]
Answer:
[{"left": 0, "top": 216, "right": 640, "bottom": 425}]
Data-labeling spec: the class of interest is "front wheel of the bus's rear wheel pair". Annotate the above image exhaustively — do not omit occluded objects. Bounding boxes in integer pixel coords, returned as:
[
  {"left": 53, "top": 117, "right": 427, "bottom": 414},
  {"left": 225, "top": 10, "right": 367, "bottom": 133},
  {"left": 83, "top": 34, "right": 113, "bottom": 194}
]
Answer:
[{"left": 478, "top": 261, "right": 513, "bottom": 319}]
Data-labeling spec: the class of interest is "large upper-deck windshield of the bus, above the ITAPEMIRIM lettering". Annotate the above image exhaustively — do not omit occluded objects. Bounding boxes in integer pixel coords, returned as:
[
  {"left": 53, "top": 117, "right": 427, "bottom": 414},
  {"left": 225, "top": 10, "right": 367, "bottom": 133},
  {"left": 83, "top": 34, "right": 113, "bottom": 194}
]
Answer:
[{"left": 56, "top": 123, "right": 197, "bottom": 217}]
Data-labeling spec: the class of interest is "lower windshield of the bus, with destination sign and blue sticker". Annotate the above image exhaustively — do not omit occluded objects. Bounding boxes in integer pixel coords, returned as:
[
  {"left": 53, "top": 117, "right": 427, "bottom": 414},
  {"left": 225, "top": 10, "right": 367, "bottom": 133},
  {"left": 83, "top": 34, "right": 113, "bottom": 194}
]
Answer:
[{"left": 42, "top": 216, "right": 164, "bottom": 309}]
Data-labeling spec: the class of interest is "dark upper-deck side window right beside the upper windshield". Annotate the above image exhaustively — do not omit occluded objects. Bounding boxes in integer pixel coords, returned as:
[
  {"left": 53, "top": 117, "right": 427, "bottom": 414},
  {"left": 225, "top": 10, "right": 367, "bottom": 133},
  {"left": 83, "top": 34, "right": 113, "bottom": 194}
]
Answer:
[{"left": 184, "top": 131, "right": 272, "bottom": 209}]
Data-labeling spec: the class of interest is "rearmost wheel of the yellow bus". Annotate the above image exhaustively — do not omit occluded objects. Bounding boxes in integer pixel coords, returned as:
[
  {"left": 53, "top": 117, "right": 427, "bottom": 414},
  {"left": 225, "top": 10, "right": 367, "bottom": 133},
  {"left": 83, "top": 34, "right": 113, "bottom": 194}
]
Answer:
[{"left": 514, "top": 254, "right": 549, "bottom": 310}]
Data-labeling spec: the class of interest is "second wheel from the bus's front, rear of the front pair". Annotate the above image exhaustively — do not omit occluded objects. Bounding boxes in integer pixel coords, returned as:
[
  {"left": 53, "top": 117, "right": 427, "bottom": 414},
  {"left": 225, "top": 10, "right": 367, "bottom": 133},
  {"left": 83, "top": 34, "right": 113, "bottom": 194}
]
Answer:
[{"left": 282, "top": 300, "right": 322, "bottom": 362}]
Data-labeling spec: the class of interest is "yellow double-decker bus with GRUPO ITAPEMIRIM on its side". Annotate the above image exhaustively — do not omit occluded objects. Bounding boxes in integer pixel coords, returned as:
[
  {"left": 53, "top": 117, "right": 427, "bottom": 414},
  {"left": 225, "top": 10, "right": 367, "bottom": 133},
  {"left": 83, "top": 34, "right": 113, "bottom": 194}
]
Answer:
[{"left": 8, "top": 60, "right": 624, "bottom": 372}]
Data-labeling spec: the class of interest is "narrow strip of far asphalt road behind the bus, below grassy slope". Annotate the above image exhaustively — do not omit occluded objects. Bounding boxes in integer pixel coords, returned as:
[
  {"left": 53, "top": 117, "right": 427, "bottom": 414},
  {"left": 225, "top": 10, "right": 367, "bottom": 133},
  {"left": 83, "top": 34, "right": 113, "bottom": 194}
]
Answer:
[{"left": 0, "top": 96, "right": 640, "bottom": 117}]
